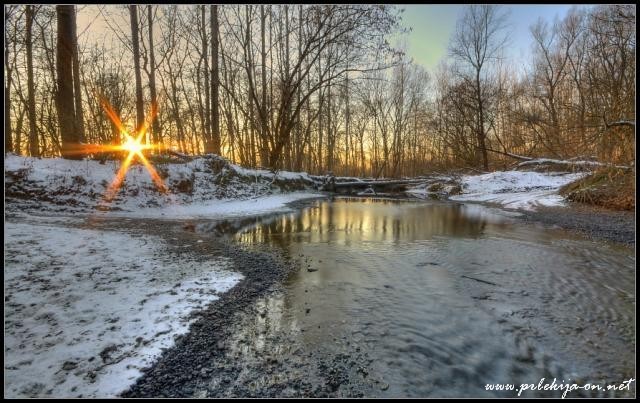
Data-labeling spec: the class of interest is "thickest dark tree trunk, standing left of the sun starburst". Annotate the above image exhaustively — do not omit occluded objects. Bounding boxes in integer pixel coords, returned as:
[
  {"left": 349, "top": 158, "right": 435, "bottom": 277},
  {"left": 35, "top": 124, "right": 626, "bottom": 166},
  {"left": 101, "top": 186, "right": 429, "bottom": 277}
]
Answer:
[{"left": 56, "top": 6, "right": 82, "bottom": 159}]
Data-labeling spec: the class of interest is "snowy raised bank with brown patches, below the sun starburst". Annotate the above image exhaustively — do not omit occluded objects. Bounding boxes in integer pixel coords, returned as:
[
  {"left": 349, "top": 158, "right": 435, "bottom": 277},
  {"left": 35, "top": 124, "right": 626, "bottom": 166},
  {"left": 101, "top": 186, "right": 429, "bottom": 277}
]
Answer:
[{"left": 5, "top": 154, "right": 322, "bottom": 218}]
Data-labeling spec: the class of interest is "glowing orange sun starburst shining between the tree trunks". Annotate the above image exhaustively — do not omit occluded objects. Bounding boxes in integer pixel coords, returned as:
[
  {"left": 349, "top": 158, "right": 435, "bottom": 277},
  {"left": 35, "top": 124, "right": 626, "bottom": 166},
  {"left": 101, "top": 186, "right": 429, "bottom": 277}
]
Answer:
[{"left": 66, "top": 98, "right": 168, "bottom": 202}]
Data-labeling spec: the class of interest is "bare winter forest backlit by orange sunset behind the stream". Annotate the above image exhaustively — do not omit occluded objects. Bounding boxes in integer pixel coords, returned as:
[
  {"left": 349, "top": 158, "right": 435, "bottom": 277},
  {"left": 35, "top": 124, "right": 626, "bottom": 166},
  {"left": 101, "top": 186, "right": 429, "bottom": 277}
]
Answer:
[{"left": 4, "top": 4, "right": 636, "bottom": 178}]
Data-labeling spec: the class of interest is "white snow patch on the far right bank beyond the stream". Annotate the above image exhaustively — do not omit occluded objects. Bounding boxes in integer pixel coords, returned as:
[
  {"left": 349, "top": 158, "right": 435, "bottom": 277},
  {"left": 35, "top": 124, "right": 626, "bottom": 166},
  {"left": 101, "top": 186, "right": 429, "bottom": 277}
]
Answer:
[{"left": 450, "top": 171, "right": 587, "bottom": 210}]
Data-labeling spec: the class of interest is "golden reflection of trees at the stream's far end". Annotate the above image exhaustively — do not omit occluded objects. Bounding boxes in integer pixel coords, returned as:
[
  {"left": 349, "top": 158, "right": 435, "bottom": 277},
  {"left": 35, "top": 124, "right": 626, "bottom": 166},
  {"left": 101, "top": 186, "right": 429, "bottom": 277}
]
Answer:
[{"left": 237, "top": 199, "right": 500, "bottom": 251}]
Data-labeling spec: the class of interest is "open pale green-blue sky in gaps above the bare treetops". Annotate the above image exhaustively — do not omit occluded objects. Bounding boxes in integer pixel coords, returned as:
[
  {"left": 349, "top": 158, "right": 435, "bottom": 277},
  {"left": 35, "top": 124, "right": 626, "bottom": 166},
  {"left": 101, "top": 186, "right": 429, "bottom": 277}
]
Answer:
[{"left": 399, "top": 4, "right": 572, "bottom": 70}]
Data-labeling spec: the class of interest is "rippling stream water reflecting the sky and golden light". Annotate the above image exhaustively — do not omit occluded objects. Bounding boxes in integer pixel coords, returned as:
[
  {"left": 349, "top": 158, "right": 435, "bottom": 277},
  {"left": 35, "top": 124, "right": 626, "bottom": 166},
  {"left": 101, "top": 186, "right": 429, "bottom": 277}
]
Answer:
[{"left": 219, "top": 198, "right": 635, "bottom": 397}]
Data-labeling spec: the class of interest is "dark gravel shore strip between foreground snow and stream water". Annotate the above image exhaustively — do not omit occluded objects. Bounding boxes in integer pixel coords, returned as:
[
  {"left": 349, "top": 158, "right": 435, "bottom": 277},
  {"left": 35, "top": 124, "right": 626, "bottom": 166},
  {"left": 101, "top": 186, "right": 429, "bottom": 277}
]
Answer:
[{"left": 116, "top": 213, "right": 378, "bottom": 398}]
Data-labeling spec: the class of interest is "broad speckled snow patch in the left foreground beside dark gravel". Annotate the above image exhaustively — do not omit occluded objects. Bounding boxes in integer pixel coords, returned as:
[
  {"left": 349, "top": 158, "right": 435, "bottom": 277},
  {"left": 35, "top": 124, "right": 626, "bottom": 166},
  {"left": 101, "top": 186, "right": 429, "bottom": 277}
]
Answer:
[{"left": 4, "top": 220, "right": 242, "bottom": 397}]
